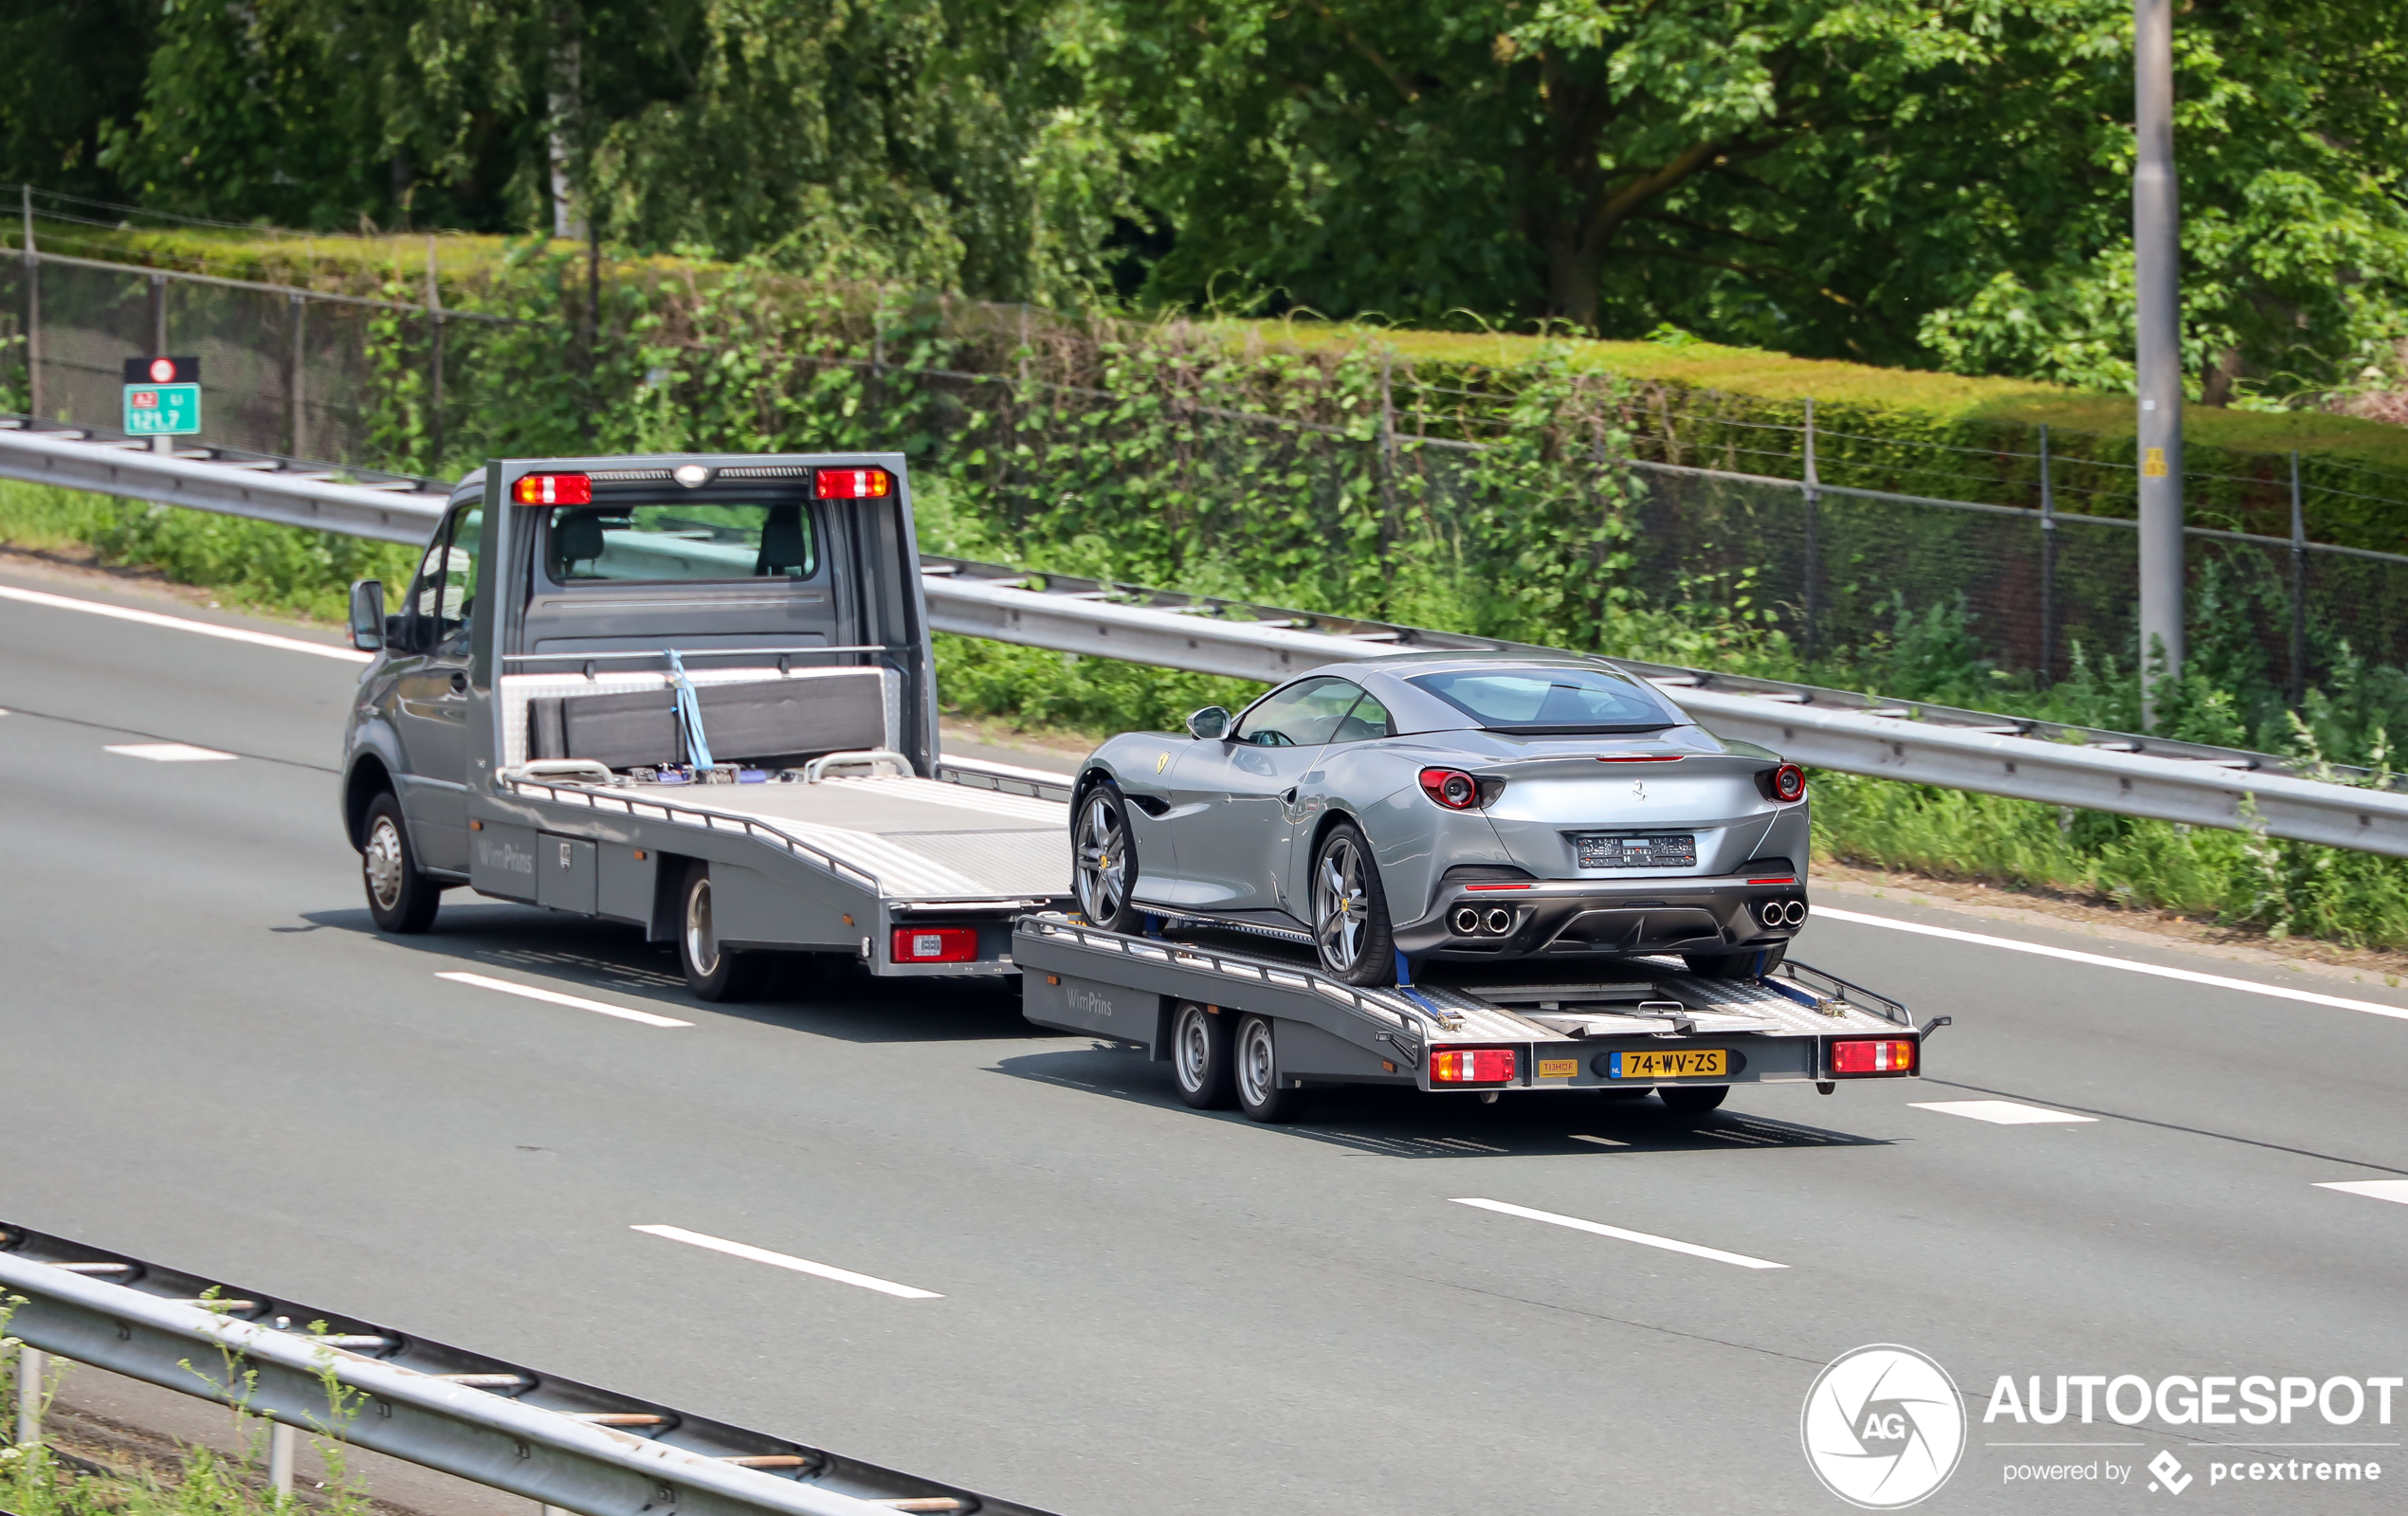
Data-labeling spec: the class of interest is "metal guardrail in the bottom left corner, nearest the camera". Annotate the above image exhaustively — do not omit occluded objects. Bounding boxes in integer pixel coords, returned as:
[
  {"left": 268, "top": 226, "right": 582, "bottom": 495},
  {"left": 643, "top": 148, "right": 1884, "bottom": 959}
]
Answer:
[{"left": 0, "top": 1225, "right": 1043, "bottom": 1516}]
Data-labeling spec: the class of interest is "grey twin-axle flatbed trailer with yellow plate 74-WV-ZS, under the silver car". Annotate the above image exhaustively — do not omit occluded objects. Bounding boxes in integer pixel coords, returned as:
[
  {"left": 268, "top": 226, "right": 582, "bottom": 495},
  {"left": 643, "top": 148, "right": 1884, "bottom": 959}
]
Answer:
[{"left": 1012, "top": 912, "right": 1948, "bottom": 1122}]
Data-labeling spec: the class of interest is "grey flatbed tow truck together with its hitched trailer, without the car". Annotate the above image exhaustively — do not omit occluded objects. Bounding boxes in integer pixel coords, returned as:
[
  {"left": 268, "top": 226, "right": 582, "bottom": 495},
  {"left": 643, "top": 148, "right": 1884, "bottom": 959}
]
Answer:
[{"left": 342, "top": 452, "right": 1945, "bottom": 1122}]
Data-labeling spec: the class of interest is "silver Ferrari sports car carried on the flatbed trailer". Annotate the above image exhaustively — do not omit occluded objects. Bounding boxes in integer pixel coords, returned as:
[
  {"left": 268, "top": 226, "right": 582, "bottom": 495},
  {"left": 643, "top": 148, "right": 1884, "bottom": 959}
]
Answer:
[{"left": 1069, "top": 652, "right": 1806, "bottom": 984}]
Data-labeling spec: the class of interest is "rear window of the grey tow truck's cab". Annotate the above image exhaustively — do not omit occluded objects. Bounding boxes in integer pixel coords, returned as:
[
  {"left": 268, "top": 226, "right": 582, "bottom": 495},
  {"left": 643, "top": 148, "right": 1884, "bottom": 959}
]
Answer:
[{"left": 544, "top": 501, "right": 819, "bottom": 585}]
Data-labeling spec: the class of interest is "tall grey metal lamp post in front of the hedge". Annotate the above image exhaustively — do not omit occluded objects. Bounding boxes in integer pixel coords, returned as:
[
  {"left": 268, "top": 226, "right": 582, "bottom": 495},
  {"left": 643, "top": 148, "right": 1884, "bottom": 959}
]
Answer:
[{"left": 2131, "top": 0, "right": 2181, "bottom": 727}]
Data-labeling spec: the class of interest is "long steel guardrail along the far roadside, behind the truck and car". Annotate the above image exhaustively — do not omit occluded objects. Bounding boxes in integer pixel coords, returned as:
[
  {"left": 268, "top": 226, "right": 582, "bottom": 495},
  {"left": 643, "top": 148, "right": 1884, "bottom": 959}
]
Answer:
[{"left": 13, "top": 416, "right": 2408, "bottom": 857}]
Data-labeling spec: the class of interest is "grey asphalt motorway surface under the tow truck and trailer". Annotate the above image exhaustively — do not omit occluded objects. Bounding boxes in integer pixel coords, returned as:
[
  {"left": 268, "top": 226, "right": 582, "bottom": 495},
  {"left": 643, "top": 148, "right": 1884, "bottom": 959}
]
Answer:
[{"left": 0, "top": 575, "right": 2408, "bottom": 1516}]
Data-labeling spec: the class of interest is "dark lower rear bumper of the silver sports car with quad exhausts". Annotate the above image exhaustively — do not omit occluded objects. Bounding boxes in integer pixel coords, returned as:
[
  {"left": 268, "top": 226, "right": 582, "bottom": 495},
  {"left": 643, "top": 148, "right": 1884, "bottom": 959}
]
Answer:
[{"left": 1396, "top": 876, "right": 1806, "bottom": 958}]
